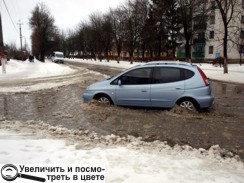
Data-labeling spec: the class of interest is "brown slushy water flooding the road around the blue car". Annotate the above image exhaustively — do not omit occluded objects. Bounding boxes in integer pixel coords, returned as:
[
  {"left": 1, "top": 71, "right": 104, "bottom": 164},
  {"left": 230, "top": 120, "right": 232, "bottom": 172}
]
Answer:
[{"left": 0, "top": 61, "right": 244, "bottom": 158}]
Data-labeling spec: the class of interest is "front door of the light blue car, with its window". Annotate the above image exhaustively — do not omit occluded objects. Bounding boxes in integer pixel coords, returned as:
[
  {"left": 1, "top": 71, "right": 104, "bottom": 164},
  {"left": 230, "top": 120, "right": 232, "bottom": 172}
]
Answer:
[{"left": 115, "top": 67, "right": 152, "bottom": 106}]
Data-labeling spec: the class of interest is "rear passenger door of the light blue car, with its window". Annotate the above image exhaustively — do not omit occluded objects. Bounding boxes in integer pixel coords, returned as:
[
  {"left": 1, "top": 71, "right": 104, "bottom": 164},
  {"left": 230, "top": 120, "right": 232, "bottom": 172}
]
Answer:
[{"left": 150, "top": 66, "right": 185, "bottom": 107}]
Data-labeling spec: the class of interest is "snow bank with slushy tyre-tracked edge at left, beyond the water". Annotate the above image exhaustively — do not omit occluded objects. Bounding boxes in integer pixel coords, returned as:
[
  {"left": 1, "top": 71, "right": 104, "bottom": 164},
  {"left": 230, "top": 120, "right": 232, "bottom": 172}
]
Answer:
[{"left": 0, "top": 60, "right": 104, "bottom": 93}]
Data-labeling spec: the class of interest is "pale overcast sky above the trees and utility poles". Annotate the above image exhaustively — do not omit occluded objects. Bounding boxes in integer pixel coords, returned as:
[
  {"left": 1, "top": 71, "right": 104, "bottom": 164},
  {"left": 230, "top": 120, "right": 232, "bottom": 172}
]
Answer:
[{"left": 0, "top": 0, "right": 125, "bottom": 47}]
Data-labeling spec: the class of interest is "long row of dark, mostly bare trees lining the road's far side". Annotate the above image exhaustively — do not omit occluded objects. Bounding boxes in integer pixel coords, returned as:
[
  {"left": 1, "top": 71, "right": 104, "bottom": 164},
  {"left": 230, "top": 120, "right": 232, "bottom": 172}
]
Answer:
[{"left": 3, "top": 0, "right": 241, "bottom": 73}]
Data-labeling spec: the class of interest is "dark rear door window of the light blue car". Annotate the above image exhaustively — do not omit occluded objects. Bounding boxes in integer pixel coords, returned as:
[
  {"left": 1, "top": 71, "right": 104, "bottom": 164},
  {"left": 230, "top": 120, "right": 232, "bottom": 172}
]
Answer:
[{"left": 153, "top": 67, "right": 183, "bottom": 84}]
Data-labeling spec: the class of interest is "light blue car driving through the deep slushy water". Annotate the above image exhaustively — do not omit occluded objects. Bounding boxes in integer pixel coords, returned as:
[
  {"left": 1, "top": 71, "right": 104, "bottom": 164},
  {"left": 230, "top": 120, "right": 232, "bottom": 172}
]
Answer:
[{"left": 83, "top": 61, "right": 214, "bottom": 110}]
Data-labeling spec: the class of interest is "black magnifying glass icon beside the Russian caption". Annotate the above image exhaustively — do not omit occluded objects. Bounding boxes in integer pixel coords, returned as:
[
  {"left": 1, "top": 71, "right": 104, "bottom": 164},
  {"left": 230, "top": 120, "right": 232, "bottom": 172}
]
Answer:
[{"left": 1, "top": 164, "right": 46, "bottom": 182}]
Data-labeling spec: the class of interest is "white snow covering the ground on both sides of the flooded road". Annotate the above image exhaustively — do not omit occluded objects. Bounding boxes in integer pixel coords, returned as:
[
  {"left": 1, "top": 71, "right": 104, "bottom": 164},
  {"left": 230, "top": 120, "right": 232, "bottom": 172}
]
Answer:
[{"left": 0, "top": 59, "right": 244, "bottom": 183}]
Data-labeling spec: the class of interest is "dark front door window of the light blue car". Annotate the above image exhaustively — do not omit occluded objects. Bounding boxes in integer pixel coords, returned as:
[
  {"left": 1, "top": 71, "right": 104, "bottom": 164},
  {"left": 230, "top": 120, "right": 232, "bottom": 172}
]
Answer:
[{"left": 119, "top": 68, "right": 152, "bottom": 85}]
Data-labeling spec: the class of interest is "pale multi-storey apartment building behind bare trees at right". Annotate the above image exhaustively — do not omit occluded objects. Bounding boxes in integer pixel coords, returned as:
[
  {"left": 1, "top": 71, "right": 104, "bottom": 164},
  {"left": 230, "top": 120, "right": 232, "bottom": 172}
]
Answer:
[{"left": 192, "top": 0, "right": 244, "bottom": 62}]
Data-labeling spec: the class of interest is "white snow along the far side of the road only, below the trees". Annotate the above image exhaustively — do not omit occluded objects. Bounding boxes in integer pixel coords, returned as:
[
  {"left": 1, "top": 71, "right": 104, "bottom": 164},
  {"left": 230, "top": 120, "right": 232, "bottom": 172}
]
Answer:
[{"left": 0, "top": 59, "right": 244, "bottom": 83}]
